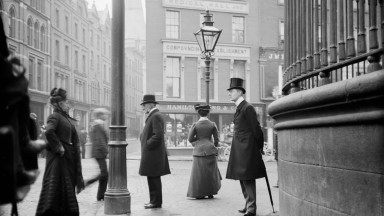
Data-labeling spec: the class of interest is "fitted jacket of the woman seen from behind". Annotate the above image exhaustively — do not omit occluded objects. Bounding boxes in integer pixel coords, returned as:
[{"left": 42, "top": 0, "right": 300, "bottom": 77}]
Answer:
[{"left": 188, "top": 120, "right": 219, "bottom": 156}]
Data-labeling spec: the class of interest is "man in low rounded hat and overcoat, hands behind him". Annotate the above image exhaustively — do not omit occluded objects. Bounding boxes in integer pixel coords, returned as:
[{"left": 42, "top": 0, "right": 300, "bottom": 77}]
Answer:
[{"left": 139, "top": 94, "right": 171, "bottom": 209}]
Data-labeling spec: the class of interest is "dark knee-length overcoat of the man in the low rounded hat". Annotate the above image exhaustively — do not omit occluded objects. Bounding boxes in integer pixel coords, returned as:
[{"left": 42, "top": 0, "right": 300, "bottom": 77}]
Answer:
[{"left": 139, "top": 109, "right": 171, "bottom": 177}]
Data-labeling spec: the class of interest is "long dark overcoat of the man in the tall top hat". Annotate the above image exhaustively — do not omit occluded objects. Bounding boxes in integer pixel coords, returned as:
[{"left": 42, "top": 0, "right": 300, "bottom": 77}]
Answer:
[{"left": 226, "top": 100, "right": 266, "bottom": 180}]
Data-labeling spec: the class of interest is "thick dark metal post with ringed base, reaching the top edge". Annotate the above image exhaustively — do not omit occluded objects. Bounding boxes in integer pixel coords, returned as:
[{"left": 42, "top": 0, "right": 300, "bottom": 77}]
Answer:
[{"left": 104, "top": 0, "right": 131, "bottom": 215}]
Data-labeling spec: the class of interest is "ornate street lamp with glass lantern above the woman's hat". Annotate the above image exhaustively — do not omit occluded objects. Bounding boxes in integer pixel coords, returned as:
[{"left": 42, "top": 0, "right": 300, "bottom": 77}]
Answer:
[{"left": 194, "top": 10, "right": 223, "bottom": 105}]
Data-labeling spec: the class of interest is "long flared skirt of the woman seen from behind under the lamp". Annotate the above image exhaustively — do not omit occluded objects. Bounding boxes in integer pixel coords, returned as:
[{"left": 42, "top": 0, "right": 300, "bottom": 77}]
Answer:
[{"left": 187, "top": 155, "right": 221, "bottom": 198}]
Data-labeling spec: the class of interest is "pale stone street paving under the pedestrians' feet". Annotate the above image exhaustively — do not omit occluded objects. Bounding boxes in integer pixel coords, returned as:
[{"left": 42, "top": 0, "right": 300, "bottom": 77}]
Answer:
[{"left": 0, "top": 139, "right": 279, "bottom": 216}]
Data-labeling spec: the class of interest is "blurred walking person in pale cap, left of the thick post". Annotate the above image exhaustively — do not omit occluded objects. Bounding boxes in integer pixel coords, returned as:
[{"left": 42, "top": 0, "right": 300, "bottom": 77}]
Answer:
[{"left": 87, "top": 108, "right": 109, "bottom": 201}]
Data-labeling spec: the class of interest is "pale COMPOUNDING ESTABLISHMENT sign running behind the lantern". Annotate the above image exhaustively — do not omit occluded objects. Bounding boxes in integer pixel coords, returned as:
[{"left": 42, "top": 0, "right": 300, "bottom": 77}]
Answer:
[{"left": 163, "top": 42, "right": 250, "bottom": 58}]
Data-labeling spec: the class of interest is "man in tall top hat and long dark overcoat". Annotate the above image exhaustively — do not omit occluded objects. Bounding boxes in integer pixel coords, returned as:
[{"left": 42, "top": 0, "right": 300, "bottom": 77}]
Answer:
[{"left": 226, "top": 78, "right": 266, "bottom": 216}]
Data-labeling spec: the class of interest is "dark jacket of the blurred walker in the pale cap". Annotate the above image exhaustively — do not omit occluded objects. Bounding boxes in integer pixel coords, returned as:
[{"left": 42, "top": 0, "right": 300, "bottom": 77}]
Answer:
[{"left": 89, "top": 122, "right": 108, "bottom": 159}]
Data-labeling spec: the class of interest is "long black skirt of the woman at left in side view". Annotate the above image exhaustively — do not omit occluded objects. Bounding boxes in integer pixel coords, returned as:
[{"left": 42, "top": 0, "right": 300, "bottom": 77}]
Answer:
[{"left": 36, "top": 144, "right": 79, "bottom": 216}]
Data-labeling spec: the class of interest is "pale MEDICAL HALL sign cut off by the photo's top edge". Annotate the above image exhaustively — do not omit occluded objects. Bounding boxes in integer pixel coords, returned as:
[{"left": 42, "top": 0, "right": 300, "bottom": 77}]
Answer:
[{"left": 163, "top": 0, "right": 249, "bottom": 14}]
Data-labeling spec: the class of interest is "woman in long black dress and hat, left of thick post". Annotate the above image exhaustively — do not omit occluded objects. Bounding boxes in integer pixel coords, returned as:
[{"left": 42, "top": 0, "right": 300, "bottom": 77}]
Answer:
[{"left": 36, "top": 88, "right": 84, "bottom": 216}]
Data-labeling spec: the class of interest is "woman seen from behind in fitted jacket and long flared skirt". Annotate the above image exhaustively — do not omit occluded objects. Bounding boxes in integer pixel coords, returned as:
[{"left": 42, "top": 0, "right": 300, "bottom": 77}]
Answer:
[{"left": 187, "top": 104, "right": 221, "bottom": 199}]
